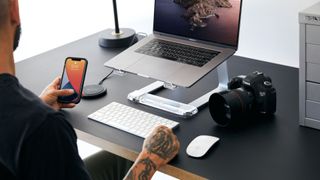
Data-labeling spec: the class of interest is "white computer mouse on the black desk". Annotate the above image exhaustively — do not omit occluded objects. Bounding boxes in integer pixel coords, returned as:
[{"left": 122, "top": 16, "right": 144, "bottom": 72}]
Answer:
[{"left": 186, "top": 135, "right": 219, "bottom": 158}]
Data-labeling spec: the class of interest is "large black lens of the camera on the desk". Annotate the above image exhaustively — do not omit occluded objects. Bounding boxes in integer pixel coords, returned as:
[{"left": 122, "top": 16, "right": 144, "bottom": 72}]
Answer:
[{"left": 209, "top": 88, "right": 254, "bottom": 127}]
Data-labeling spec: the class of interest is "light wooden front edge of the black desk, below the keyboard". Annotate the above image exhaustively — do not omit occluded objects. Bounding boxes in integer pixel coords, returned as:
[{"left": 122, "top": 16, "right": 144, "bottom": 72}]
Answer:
[{"left": 75, "top": 129, "right": 206, "bottom": 180}]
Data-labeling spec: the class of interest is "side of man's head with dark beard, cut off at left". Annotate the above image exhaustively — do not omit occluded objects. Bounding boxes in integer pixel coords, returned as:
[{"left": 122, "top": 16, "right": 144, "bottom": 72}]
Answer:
[{"left": 0, "top": 0, "right": 21, "bottom": 50}]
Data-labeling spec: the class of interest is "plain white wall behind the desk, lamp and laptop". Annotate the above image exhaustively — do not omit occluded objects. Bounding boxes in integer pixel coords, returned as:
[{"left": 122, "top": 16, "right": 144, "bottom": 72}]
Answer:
[{"left": 15, "top": 0, "right": 318, "bottom": 67}]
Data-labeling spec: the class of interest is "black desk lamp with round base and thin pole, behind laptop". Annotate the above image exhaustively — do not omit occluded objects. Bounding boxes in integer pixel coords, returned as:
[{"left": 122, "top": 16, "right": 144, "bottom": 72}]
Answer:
[{"left": 99, "top": 0, "right": 137, "bottom": 48}]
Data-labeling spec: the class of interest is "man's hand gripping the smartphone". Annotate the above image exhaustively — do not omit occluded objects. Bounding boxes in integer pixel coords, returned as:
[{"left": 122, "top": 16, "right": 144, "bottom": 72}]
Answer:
[{"left": 40, "top": 77, "right": 76, "bottom": 110}]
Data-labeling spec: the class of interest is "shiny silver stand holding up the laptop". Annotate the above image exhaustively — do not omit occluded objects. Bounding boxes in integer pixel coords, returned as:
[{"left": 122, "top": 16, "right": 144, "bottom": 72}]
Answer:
[{"left": 127, "top": 61, "right": 229, "bottom": 117}]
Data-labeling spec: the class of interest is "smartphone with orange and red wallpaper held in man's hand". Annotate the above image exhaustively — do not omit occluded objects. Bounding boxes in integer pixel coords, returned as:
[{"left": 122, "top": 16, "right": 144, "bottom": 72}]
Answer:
[{"left": 58, "top": 57, "right": 88, "bottom": 104}]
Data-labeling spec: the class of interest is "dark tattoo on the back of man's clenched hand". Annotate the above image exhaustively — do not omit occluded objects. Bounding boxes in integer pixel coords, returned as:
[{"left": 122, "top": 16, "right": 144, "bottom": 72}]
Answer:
[{"left": 146, "top": 129, "right": 177, "bottom": 159}]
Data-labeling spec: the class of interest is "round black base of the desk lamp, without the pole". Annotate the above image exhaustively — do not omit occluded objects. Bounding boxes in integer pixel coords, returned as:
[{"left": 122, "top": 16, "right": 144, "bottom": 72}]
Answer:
[{"left": 99, "top": 28, "right": 137, "bottom": 48}]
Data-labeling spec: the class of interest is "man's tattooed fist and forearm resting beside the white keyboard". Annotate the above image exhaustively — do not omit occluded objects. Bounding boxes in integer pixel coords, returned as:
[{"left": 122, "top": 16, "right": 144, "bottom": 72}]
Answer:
[{"left": 124, "top": 126, "right": 180, "bottom": 180}]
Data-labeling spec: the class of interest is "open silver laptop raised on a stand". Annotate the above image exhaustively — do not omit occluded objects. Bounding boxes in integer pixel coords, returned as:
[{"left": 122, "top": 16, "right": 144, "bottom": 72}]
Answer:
[{"left": 104, "top": 0, "right": 242, "bottom": 87}]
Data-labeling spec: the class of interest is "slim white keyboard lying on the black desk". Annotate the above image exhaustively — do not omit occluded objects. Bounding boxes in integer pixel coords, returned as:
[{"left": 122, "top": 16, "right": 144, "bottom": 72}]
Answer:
[{"left": 88, "top": 102, "right": 179, "bottom": 138}]
